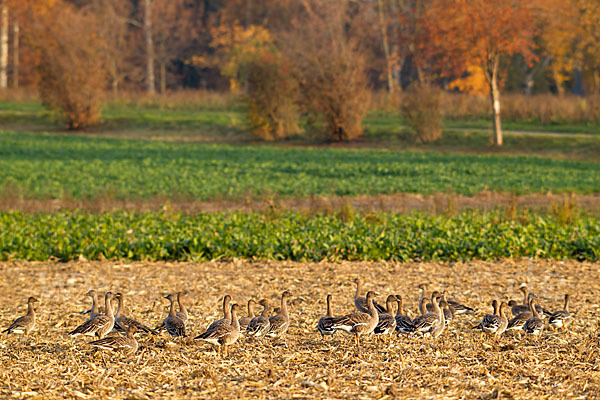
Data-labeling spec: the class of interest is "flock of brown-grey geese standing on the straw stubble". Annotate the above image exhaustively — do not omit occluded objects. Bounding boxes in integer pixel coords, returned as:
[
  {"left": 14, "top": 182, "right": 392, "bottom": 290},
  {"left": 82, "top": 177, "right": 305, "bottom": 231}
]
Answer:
[{"left": 3, "top": 278, "right": 572, "bottom": 356}]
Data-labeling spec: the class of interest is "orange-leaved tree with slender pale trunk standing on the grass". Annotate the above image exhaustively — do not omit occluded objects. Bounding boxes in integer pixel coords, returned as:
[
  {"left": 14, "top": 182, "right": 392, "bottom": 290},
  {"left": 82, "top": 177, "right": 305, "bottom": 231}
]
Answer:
[{"left": 427, "top": 0, "right": 537, "bottom": 146}]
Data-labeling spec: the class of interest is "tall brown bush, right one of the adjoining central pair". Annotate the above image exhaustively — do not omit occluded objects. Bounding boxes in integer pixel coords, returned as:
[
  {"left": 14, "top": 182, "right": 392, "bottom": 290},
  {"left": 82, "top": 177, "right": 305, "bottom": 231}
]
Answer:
[{"left": 282, "top": 0, "right": 371, "bottom": 141}]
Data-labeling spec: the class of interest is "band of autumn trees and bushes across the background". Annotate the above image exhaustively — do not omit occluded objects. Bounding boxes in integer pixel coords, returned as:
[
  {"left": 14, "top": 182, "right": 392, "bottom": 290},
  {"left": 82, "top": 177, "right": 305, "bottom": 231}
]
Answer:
[{"left": 0, "top": 0, "right": 600, "bottom": 145}]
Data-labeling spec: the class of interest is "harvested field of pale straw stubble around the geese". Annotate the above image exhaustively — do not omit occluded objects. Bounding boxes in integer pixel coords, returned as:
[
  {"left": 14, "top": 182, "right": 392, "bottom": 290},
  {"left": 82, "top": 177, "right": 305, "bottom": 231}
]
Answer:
[{"left": 0, "top": 260, "right": 600, "bottom": 399}]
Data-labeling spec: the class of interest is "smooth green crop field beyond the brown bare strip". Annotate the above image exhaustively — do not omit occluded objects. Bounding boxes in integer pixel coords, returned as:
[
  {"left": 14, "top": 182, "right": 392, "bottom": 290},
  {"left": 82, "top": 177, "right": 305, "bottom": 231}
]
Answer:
[{"left": 0, "top": 132, "right": 600, "bottom": 200}]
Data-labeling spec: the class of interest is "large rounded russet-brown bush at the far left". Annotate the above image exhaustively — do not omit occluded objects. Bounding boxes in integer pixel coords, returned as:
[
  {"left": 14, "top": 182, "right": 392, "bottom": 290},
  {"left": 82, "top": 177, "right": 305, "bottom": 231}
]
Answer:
[{"left": 32, "top": 4, "right": 107, "bottom": 129}]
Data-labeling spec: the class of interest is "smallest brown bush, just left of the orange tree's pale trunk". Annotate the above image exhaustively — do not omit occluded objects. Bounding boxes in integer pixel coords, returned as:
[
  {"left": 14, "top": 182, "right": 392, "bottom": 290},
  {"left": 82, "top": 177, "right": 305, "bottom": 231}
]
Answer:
[{"left": 402, "top": 85, "right": 442, "bottom": 143}]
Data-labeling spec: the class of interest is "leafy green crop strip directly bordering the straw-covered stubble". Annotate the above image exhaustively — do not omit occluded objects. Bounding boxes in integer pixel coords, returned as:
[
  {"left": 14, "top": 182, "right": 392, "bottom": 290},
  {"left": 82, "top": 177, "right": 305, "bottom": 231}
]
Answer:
[{"left": 0, "top": 212, "right": 600, "bottom": 261}]
